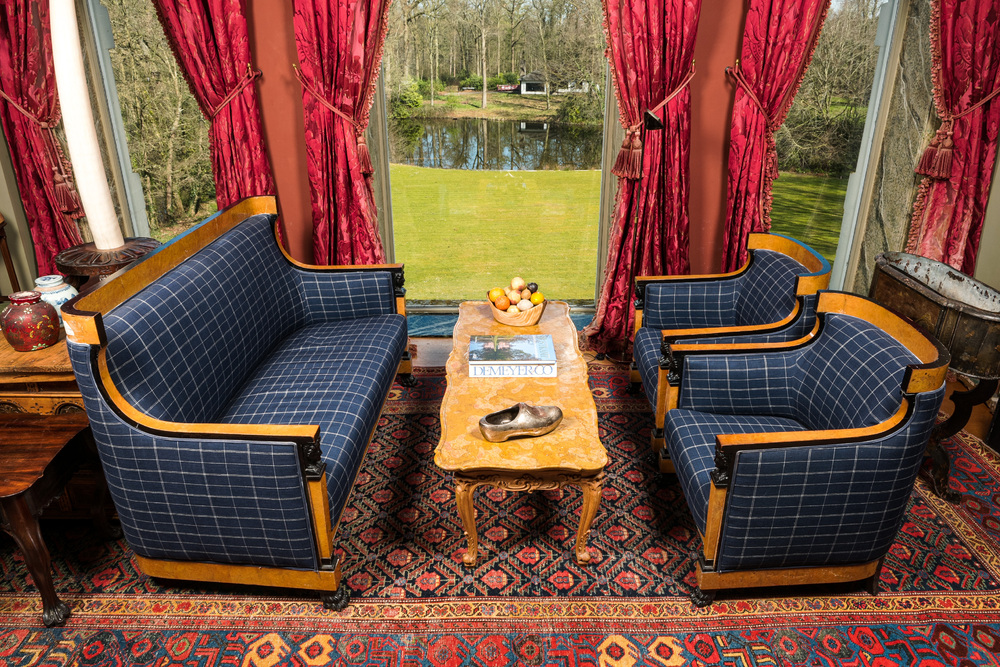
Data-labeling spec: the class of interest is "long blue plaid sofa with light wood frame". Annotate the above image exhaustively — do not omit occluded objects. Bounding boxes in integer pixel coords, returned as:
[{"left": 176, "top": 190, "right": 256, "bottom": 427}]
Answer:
[{"left": 63, "top": 197, "right": 412, "bottom": 608}]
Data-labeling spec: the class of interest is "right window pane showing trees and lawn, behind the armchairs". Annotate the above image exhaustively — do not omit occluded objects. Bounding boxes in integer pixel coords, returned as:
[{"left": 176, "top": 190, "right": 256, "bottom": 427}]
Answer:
[{"left": 771, "top": 0, "right": 888, "bottom": 264}]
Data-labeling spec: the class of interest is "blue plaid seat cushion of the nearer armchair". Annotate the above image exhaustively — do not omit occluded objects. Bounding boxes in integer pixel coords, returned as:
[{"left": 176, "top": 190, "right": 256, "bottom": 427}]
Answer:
[{"left": 663, "top": 409, "right": 805, "bottom": 535}]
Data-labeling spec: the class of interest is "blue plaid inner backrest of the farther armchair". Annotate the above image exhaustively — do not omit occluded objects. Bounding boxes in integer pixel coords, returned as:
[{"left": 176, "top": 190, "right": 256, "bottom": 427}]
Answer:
[{"left": 736, "top": 248, "right": 810, "bottom": 326}]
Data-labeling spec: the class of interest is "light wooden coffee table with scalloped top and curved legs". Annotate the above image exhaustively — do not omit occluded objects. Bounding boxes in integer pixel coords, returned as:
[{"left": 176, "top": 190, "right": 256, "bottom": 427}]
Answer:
[{"left": 434, "top": 301, "right": 608, "bottom": 565}]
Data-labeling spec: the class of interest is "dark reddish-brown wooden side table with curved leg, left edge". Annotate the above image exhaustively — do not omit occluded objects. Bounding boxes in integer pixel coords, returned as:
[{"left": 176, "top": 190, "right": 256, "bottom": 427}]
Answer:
[{"left": 0, "top": 412, "right": 90, "bottom": 626}]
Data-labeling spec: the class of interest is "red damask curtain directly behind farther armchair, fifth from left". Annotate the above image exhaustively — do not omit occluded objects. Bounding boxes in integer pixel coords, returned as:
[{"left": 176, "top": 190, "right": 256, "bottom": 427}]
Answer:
[{"left": 722, "top": 0, "right": 830, "bottom": 271}]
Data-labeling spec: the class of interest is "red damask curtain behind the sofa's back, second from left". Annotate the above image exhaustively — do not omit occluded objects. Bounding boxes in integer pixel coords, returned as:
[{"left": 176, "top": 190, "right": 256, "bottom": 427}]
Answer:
[{"left": 155, "top": 0, "right": 274, "bottom": 209}]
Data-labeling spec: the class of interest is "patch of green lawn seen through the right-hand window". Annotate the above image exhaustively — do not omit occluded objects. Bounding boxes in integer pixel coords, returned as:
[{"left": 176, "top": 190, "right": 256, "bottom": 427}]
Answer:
[{"left": 771, "top": 171, "right": 847, "bottom": 264}]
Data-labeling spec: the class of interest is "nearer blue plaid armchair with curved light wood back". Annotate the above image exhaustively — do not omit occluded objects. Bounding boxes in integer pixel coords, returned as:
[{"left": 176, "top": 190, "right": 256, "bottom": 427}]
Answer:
[{"left": 664, "top": 292, "right": 949, "bottom": 605}]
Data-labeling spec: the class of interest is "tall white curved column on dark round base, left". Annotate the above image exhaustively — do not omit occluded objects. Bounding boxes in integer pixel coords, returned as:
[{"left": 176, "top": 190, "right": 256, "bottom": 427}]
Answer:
[{"left": 49, "top": 0, "right": 125, "bottom": 250}]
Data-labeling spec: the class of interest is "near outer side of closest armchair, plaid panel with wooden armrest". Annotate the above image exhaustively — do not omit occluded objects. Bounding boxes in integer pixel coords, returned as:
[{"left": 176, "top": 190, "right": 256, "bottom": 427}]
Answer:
[{"left": 704, "top": 386, "right": 944, "bottom": 571}]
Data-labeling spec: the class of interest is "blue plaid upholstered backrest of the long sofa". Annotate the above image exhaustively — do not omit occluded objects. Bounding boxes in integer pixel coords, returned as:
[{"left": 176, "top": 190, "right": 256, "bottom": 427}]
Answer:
[{"left": 104, "top": 214, "right": 305, "bottom": 422}]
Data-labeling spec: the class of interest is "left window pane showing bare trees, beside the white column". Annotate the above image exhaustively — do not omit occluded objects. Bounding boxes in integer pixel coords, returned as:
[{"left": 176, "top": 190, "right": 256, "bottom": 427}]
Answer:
[{"left": 101, "top": 0, "right": 216, "bottom": 241}]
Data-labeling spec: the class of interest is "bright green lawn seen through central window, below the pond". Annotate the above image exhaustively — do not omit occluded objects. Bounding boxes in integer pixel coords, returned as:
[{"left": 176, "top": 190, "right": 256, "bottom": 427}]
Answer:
[{"left": 389, "top": 164, "right": 601, "bottom": 301}]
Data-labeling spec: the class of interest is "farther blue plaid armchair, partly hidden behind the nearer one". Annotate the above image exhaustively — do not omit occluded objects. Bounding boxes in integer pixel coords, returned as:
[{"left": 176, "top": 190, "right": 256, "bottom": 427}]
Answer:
[{"left": 632, "top": 233, "right": 830, "bottom": 456}]
